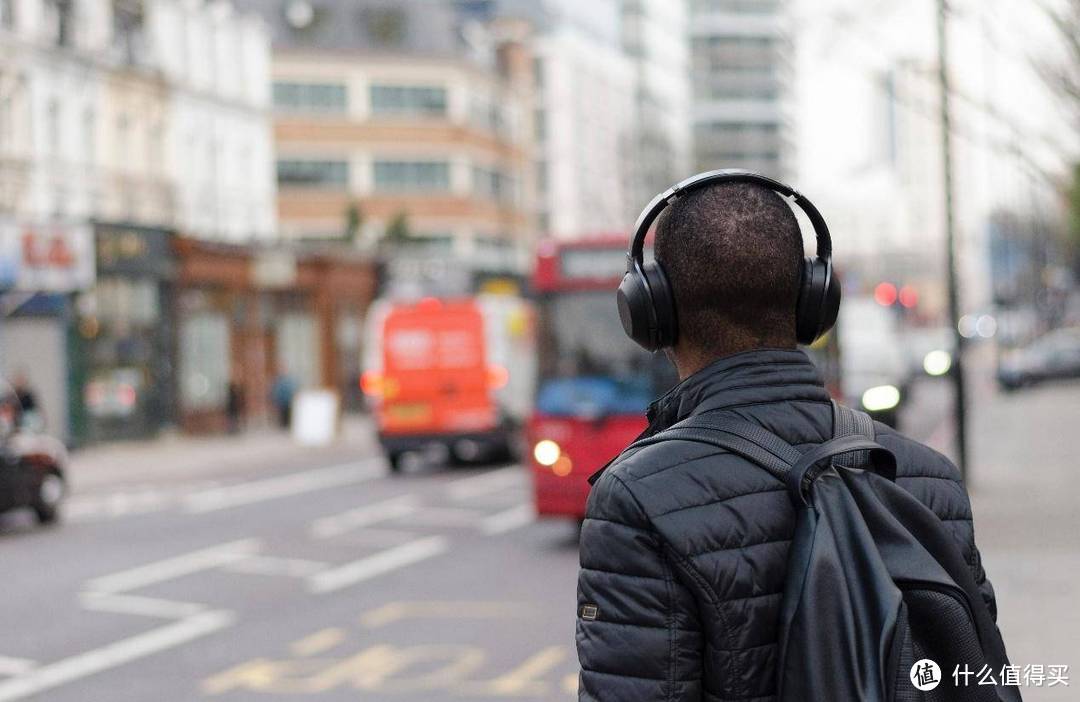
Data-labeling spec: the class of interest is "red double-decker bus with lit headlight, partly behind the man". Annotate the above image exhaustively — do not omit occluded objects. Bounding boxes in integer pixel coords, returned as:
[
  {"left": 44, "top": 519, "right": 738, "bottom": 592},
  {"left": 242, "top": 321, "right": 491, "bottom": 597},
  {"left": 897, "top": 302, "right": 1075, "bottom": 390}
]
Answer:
[{"left": 526, "top": 237, "right": 676, "bottom": 519}]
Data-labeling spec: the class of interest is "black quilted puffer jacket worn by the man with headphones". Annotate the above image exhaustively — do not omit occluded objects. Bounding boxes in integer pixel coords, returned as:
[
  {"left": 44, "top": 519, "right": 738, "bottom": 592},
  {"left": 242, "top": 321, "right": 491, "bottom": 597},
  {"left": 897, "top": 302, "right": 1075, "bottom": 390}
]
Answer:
[{"left": 577, "top": 350, "right": 997, "bottom": 702}]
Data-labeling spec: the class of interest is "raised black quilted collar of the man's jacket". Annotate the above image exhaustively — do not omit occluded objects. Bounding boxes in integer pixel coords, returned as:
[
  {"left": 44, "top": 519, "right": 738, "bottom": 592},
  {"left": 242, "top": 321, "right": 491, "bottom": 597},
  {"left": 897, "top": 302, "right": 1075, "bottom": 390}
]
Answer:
[{"left": 589, "top": 349, "right": 829, "bottom": 484}]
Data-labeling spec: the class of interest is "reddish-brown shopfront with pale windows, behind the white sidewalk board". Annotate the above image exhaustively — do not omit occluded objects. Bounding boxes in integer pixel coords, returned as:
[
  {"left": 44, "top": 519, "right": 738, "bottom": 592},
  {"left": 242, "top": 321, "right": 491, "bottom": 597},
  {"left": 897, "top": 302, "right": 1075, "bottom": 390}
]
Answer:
[{"left": 176, "top": 239, "right": 375, "bottom": 432}]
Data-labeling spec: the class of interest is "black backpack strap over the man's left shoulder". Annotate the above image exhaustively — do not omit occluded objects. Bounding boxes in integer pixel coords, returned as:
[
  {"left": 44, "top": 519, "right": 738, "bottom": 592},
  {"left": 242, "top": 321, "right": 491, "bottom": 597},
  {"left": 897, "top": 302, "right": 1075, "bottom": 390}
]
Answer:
[{"left": 626, "top": 413, "right": 801, "bottom": 482}]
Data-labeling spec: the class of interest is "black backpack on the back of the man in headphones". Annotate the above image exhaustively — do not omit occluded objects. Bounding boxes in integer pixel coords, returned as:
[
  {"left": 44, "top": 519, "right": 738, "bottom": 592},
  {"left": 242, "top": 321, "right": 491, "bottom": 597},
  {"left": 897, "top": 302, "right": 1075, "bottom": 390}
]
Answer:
[{"left": 632, "top": 403, "right": 1021, "bottom": 702}]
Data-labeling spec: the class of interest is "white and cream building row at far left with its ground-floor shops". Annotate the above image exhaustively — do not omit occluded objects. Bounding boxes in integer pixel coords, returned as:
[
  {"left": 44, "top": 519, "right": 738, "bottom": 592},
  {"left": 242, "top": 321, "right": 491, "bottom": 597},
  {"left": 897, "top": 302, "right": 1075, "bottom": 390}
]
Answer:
[{"left": 0, "top": 0, "right": 276, "bottom": 437}]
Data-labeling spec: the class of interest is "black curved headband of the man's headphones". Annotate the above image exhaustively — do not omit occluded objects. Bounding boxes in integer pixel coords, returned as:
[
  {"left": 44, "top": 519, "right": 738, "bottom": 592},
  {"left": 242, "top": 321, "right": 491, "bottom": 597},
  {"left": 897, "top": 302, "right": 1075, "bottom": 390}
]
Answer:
[{"left": 626, "top": 168, "right": 833, "bottom": 265}]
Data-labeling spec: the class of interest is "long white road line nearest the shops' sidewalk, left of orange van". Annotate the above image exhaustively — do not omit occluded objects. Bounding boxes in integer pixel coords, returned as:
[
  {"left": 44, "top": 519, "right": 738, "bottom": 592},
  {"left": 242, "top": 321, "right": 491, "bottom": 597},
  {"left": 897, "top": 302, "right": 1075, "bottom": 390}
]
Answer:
[{"left": 184, "top": 458, "right": 386, "bottom": 514}]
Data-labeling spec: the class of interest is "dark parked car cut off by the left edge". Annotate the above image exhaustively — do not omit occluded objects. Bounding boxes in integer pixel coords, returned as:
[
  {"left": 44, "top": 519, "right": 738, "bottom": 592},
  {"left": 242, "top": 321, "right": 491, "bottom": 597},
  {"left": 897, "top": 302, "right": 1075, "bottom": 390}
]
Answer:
[{"left": 0, "top": 381, "right": 67, "bottom": 524}]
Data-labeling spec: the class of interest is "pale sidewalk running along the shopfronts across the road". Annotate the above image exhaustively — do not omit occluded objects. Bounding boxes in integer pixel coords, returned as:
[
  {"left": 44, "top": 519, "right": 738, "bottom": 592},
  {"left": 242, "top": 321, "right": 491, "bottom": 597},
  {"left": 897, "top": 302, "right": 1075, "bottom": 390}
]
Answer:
[{"left": 69, "top": 415, "right": 378, "bottom": 491}]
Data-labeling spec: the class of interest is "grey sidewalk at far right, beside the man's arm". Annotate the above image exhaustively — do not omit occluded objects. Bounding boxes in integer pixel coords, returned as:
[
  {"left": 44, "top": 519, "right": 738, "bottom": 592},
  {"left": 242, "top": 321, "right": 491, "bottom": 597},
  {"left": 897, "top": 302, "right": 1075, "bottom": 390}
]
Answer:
[{"left": 968, "top": 372, "right": 1080, "bottom": 702}]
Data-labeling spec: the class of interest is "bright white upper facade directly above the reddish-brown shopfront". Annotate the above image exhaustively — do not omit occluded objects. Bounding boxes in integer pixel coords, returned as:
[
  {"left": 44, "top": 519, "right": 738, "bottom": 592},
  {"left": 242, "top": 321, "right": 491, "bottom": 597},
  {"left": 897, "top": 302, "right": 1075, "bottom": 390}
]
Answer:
[{"left": 145, "top": 0, "right": 276, "bottom": 241}]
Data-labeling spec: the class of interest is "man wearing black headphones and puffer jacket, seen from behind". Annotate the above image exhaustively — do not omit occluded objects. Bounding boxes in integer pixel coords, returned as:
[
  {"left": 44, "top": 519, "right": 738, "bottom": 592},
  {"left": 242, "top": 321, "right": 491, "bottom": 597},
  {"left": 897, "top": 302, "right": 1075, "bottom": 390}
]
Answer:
[{"left": 577, "top": 172, "right": 1006, "bottom": 702}]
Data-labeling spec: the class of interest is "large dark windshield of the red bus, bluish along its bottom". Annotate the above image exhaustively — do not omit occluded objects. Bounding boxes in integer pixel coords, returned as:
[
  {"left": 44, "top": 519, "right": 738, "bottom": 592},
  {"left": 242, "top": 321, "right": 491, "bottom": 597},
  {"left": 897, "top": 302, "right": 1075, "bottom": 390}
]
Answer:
[{"left": 536, "top": 291, "right": 676, "bottom": 418}]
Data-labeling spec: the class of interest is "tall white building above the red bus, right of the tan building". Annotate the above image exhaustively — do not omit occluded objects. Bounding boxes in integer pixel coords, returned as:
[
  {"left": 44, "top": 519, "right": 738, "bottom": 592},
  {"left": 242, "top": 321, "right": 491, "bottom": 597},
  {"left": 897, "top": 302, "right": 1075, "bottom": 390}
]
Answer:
[{"left": 501, "top": 0, "right": 638, "bottom": 240}]
